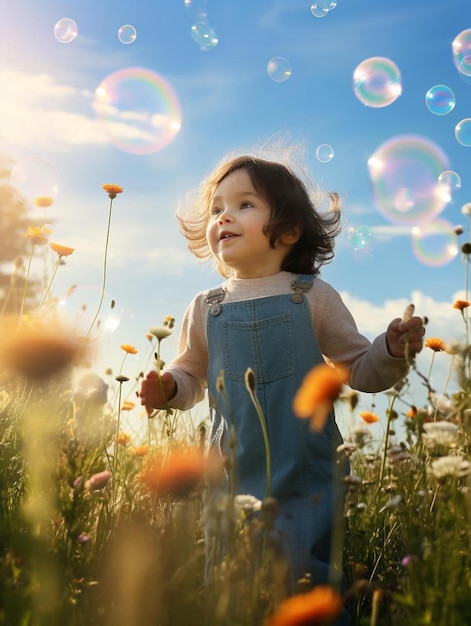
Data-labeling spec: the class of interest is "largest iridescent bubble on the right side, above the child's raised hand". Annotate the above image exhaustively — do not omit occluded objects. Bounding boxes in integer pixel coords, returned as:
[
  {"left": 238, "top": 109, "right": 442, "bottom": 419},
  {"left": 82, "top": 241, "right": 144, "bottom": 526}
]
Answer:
[{"left": 368, "top": 135, "right": 448, "bottom": 226}]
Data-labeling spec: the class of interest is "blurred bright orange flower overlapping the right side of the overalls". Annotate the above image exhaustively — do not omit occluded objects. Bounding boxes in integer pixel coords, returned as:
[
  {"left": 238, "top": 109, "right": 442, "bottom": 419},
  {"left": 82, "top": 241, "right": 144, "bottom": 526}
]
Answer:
[{"left": 293, "top": 363, "right": 349, "bottom": 430}]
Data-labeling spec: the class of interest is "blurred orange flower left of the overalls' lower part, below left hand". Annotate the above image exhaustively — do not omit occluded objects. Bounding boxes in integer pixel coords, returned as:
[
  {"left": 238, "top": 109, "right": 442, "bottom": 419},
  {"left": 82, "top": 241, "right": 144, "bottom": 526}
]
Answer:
[{"left": 141, "top": 448, "right": 222, "bottom": 496}]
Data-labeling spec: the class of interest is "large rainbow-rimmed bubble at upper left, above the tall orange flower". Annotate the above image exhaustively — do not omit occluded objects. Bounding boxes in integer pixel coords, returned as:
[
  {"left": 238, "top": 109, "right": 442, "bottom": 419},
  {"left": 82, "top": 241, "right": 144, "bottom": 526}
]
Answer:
[{"left": 93, "top": 67, "right": 181, "bottom": 154}]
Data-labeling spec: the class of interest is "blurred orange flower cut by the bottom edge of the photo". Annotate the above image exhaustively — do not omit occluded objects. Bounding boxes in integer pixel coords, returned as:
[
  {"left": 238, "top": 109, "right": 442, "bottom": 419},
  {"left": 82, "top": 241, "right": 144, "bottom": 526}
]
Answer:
[{"left": 264, "top": 585, "right": 343, "bottom": 626}]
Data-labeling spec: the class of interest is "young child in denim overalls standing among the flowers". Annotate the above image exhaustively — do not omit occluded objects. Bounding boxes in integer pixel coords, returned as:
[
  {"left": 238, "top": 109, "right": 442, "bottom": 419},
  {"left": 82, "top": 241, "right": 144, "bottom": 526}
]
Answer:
[{"left": 140, "top": 156, "right": 425, "bottom": 616}]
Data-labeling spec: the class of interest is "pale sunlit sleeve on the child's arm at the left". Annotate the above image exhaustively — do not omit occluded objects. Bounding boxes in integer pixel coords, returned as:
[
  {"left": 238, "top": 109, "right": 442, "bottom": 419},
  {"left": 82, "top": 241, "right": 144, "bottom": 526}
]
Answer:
[{"left": 164, "top": 294, "right": 208, "bottom": 411}]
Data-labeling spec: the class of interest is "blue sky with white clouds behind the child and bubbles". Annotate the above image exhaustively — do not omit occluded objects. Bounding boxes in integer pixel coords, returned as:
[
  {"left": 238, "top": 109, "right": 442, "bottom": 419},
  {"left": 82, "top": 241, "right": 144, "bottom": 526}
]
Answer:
[{"left": 0, "top": 0, "right": 471, "bottom": 420}]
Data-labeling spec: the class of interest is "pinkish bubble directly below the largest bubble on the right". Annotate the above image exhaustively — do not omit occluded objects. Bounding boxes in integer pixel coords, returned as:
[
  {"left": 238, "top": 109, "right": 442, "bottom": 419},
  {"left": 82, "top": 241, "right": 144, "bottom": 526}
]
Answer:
[{"left": 412, "top": 219, "right": 459, "bottom": 267}]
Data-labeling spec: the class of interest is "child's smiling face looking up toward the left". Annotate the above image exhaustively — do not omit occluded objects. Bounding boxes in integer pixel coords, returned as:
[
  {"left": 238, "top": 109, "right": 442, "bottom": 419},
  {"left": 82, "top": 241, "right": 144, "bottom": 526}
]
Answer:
[{"left": 206, "top": 169, "right": 291, "bottom": 278}]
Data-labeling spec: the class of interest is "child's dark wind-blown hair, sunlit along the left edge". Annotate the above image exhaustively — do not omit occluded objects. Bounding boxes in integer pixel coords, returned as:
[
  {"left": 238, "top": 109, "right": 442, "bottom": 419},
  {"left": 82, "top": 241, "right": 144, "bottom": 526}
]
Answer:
[{"left": 177, "top": 156, "right": 341, "bottom": 278}]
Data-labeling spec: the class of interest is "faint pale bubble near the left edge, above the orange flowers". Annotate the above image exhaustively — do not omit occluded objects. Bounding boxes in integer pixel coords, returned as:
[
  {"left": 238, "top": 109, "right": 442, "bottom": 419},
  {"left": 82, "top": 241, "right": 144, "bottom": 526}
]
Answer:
[{"left": 10, "top": 156, "right": 59, "bottom": 204}]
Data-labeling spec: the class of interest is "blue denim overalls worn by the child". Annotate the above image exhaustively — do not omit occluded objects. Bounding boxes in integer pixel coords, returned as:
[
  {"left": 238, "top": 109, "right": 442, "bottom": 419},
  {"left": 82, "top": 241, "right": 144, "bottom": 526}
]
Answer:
[{"left": 206, "top": 275, "right": 346, "bottom": 600}]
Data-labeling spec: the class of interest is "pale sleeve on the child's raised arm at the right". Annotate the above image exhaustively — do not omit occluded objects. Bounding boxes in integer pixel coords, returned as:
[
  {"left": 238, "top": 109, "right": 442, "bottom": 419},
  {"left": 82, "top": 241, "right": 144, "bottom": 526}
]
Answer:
[{"left": 311, "top": 281, "right": 408, "bottom": 393}]
